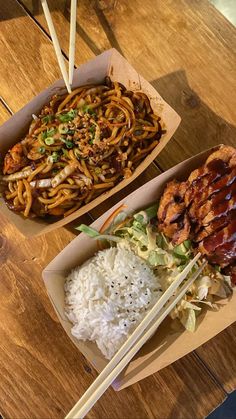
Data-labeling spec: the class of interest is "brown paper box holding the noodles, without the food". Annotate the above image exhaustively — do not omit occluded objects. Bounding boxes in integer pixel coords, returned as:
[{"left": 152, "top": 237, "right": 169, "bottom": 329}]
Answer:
[{"left": 0, "top": 49, "right": 180, "bottom": 236}]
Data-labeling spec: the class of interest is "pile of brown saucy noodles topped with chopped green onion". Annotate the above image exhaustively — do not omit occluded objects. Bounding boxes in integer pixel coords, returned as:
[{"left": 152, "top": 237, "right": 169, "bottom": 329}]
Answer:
[{"left": 1, "top": 79, "right": 163, "bottom": 217}]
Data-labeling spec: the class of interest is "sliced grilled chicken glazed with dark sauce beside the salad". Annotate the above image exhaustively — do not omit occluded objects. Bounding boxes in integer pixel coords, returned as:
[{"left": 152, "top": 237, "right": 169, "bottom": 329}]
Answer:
[{"left": 158, "top": 146, "right": 236, "bottom": 281}]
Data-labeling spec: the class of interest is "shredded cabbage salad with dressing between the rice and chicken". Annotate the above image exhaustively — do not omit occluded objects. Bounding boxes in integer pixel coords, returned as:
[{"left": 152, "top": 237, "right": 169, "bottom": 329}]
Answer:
[{"left": 77, "top": 204, "right": 232, "bottom": 332}]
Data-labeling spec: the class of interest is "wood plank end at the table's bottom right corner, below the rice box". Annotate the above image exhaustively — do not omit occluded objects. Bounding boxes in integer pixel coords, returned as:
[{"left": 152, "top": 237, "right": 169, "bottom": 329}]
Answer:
[{"left": 196, "top": 323, "right": 236, "bottom": 393}]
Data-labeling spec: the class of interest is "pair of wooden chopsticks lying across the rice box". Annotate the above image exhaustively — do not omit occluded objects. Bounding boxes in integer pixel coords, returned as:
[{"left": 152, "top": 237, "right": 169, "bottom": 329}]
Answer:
[{"left": 65, "top": 253, "right": 206, "bottom": 419}]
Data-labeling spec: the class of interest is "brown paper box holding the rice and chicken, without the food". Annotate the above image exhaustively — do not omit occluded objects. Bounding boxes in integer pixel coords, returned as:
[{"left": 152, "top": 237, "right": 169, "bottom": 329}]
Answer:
[{"left": 43, "top": 147, "right": 236, "bottom": 390}]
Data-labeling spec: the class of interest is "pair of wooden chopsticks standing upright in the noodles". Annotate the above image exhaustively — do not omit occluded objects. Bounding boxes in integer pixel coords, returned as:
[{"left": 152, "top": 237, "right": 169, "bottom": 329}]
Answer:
[{"left": 41, "top": 0, "right": 77, "bottom": 93}]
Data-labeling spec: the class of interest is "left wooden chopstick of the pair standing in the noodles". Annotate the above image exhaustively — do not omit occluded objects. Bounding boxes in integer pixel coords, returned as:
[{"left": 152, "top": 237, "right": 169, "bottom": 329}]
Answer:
[{"left": 41, "top": 0, "right": 71, "bottom": 93}]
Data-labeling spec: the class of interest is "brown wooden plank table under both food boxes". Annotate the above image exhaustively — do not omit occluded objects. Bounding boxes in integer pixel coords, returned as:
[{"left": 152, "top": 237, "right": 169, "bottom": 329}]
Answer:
[{"left": 0, "top": 0, "right": 236, "bottom": 419}]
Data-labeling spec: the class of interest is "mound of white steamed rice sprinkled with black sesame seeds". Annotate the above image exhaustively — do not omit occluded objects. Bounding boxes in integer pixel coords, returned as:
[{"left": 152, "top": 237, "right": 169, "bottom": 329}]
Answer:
[{"left": 65, "top": 246, "right": 161, "bottom": 359}]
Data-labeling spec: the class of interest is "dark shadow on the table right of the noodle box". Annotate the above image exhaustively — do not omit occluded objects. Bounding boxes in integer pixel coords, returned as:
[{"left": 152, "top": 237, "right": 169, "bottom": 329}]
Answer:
[{"left": 151, "top": 70, "right": 236, "bottom": 170}]
